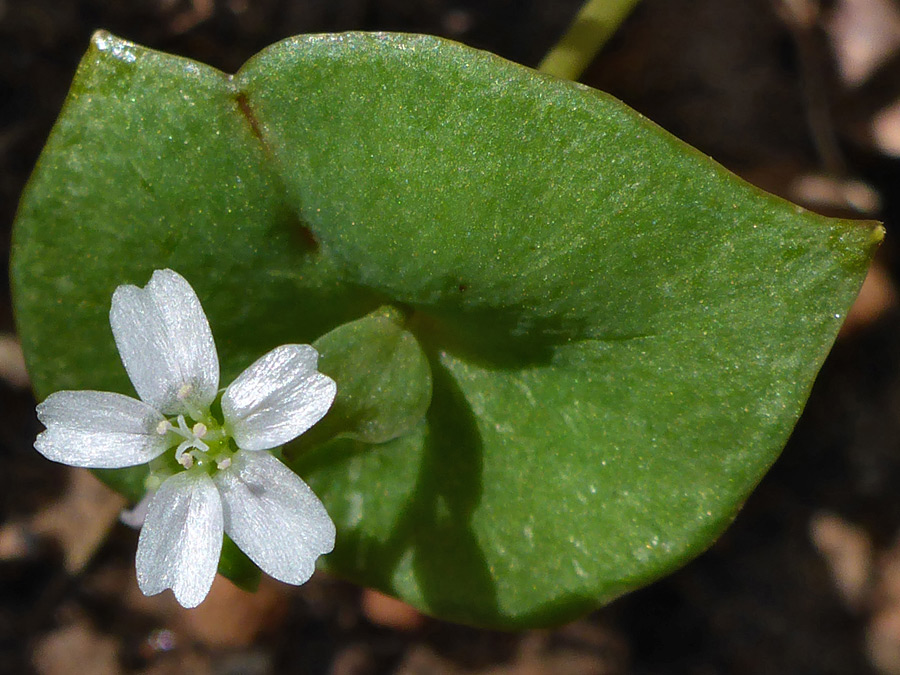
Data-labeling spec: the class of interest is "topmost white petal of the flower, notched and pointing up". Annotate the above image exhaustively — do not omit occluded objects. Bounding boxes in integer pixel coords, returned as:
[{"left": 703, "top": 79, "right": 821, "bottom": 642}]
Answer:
[{"left": 109, "top": 270, "right": 219, "bottom": 415}]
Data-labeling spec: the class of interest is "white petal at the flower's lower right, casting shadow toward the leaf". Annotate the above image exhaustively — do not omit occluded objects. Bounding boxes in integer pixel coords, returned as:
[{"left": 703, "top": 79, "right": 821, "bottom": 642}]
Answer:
[{"left": 213, "top": 452, "right": 334, "bottom": 584}]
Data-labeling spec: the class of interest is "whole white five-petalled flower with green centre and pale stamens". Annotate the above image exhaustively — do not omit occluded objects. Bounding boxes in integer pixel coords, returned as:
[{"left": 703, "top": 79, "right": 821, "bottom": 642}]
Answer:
[{"left": 35, "top": 270, "right": 336, "bottom": 607}]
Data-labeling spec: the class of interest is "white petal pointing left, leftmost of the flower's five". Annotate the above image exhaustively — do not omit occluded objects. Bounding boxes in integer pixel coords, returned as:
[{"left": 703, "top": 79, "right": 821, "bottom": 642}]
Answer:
[{"left": 34, "top": 391, "right": 168, "bottom": 469}]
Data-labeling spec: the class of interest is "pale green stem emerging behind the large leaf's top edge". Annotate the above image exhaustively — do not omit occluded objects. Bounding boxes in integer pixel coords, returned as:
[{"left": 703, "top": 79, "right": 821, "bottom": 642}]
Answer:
[{"left": 538, "top": 0, "right": 640, "bottom": 80}]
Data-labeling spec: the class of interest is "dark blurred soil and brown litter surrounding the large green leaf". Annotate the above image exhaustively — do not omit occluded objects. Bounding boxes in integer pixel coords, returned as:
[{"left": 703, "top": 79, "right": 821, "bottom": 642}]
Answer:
[{"left": 0, "top": 0, "right": 900, "bottom": 675}]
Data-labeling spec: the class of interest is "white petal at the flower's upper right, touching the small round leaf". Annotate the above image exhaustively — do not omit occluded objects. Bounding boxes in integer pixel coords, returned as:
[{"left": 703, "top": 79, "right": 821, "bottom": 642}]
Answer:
[{"left": 222, "top": 345, "right": 337, "bottom": 450}]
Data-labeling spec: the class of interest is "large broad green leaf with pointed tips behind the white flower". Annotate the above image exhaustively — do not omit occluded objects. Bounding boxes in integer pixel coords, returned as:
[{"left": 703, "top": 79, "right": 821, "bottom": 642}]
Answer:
[{"left": 12, "top": 33, "right": 881, "bottom": 627}]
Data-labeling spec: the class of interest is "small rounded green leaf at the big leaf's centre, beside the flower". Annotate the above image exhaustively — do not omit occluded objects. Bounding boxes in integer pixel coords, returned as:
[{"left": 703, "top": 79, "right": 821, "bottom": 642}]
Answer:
[{"left": 301, "top": 307, "right": 431, "bottom": 446}]
